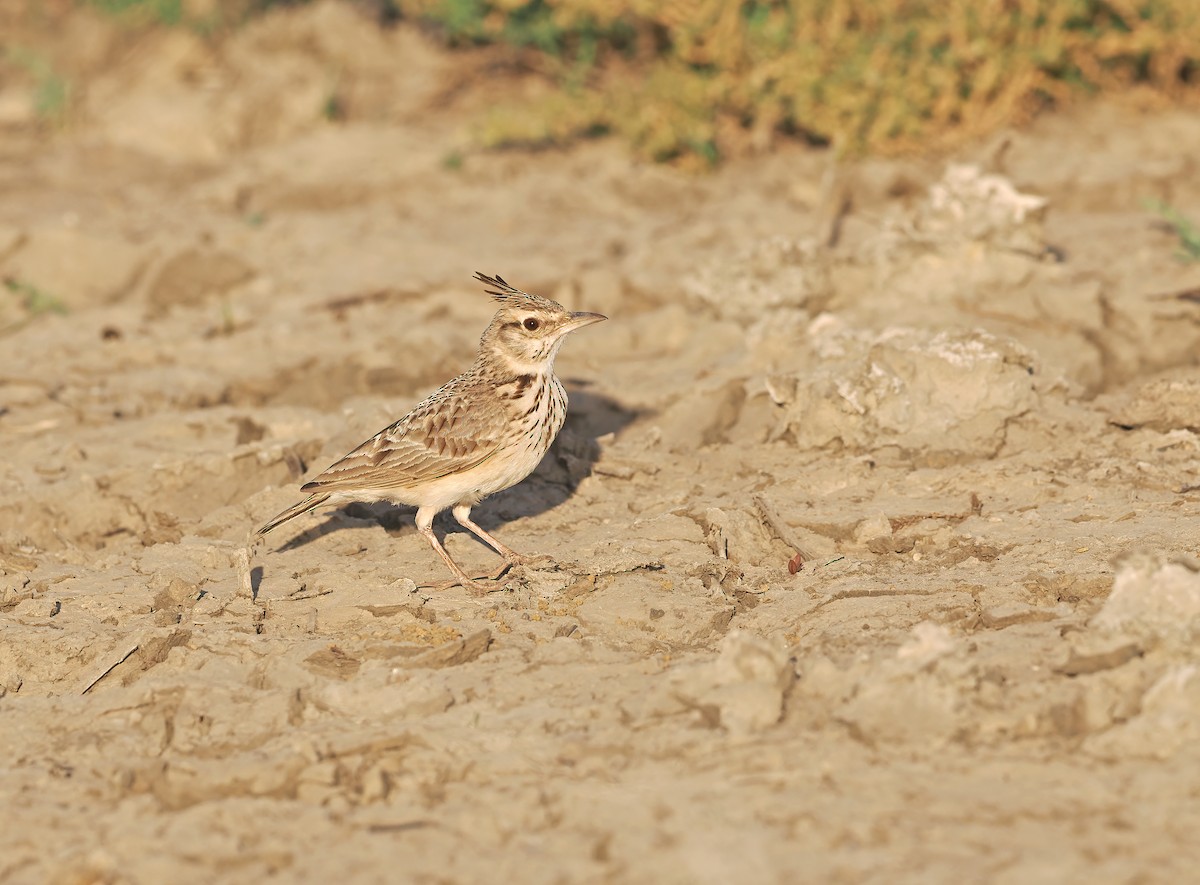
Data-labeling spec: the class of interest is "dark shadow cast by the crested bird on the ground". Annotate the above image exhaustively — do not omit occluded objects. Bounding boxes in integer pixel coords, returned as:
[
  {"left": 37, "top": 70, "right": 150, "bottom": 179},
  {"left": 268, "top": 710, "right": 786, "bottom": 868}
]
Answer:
[{"left": 277, "top": 381, "right": 641, "bottom": 552}]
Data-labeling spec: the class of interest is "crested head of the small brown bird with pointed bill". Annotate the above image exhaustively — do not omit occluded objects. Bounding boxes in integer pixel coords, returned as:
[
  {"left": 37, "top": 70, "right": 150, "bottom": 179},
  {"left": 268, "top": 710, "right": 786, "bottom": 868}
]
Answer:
[{"left": 475, "top": 273, "right": 608, "bottom": 374}]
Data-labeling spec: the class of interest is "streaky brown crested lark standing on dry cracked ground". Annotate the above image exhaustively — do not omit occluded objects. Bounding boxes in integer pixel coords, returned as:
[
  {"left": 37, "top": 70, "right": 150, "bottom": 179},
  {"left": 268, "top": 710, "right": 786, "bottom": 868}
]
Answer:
[{"left": 257, "top": 272, "right": 608, "bottom": 595}]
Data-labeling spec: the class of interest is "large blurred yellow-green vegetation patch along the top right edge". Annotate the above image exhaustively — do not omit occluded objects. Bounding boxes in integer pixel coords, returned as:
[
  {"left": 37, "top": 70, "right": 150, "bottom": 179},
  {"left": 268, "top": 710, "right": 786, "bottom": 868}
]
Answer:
[{"left": 394, "top": 0, "right": 1200, "bottom": 165}]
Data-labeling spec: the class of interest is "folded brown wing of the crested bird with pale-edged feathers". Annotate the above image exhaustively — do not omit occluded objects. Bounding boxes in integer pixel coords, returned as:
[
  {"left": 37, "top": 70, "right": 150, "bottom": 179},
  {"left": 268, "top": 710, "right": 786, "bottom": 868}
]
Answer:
[{"left": 301, "top": 379, "right": 503, "bottom": 492}]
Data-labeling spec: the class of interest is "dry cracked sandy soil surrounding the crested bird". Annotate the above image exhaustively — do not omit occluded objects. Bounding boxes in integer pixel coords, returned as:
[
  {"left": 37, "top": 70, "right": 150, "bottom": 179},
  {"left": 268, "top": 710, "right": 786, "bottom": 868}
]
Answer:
[{"left": 0, "top": 4, "right": 1200, "bottom": 883}]
